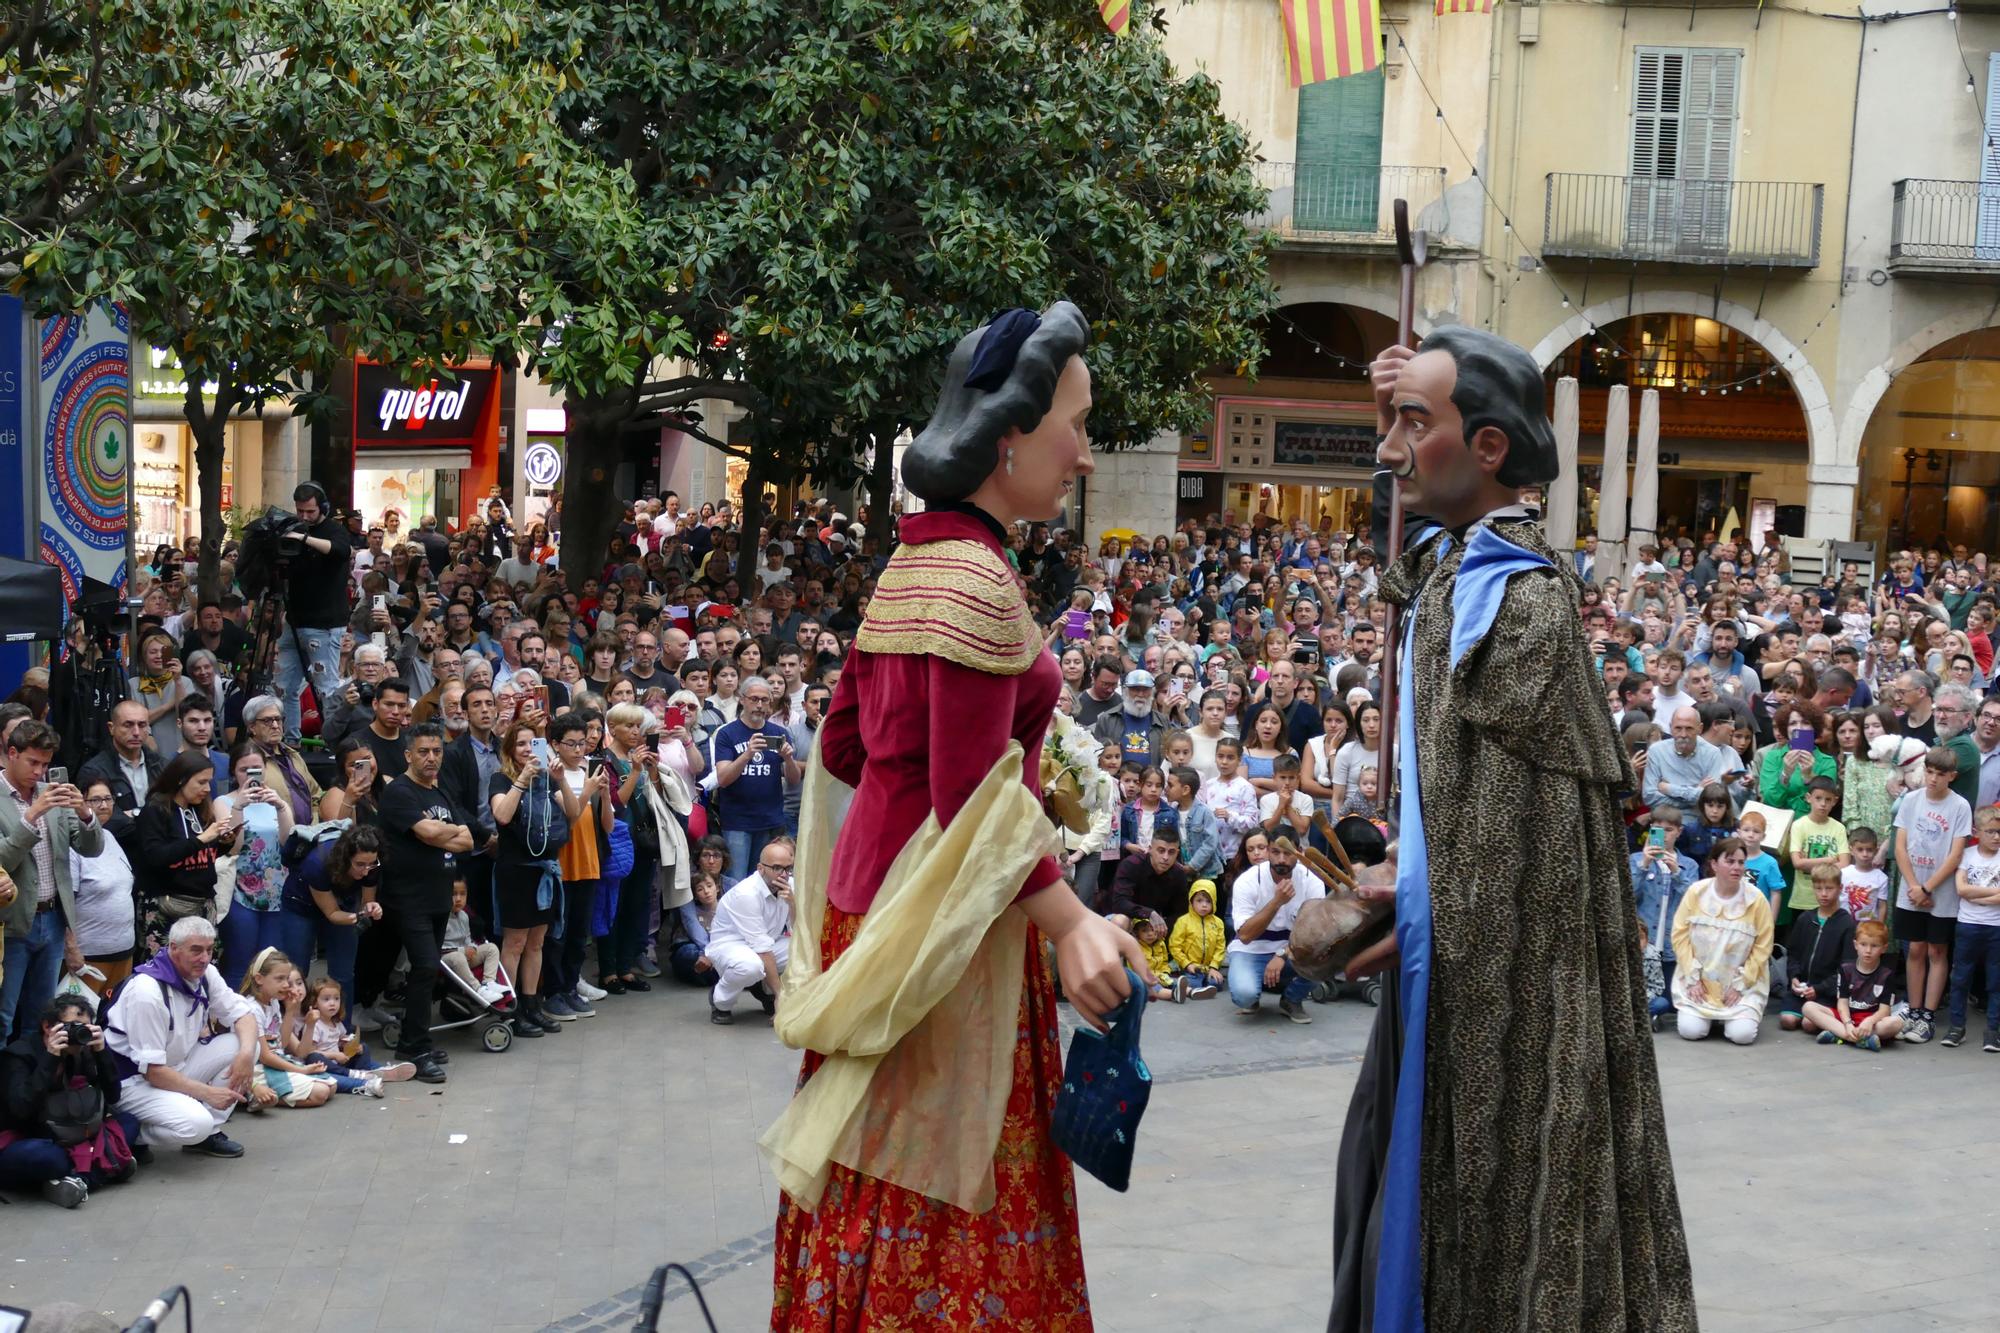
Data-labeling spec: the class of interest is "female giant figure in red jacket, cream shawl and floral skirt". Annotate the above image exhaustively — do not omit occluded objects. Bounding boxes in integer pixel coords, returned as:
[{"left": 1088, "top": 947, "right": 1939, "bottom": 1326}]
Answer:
[{"left": 762, "top": 302, "right": 1144, "bottom": 1333}]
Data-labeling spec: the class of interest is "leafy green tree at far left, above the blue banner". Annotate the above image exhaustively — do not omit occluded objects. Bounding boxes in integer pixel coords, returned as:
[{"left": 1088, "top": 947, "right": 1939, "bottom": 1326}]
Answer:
[{"left": 11, "top": 0, "right": 648, "bottom": 596}]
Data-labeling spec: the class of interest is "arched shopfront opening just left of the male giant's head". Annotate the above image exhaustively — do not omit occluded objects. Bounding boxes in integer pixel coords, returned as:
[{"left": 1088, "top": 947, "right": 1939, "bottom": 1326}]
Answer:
[{"left": 1180, "top": 300, "right": 1396, "bottom": 532}]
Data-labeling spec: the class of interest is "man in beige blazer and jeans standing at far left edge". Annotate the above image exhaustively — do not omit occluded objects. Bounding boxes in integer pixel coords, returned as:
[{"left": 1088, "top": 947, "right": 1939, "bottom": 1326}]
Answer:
[{"left": 0, "top": 719, "right": 104, "bottom": 1037}]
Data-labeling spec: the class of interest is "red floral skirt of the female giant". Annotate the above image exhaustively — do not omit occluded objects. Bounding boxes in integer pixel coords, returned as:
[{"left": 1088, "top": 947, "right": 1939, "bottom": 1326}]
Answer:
[{"left": 770, "top": 905, "right": 1090, "bottom": 1333}]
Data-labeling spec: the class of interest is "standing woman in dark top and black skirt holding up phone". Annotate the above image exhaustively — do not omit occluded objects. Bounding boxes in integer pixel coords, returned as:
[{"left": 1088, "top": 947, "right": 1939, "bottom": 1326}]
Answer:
[{"left": 486, "top": 723, "right": 576, "bottom": 1037}]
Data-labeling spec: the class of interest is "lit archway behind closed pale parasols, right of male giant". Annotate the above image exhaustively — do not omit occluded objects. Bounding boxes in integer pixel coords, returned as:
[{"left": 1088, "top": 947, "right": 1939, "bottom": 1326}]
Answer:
[{"left": 1548, "top": 310, "right": 1808, "bottom": 542}]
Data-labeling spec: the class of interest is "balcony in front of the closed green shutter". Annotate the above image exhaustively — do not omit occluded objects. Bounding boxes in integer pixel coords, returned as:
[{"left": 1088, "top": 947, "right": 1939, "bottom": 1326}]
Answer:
[{"left": 1250, "top": 162, "right": 1444, "bottom": 252}]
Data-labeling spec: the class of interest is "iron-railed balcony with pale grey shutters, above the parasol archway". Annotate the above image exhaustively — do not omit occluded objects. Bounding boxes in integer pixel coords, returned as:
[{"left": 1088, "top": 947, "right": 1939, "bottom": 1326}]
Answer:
[{"left": 1542, "top": 172, "right": 1826, "bottom": 268}]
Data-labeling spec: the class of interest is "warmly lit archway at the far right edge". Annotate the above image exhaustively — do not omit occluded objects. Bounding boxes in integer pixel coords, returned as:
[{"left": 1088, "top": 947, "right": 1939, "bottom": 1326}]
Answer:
[{"left": 1856, "top": 328, "right": 2000, "bottom": 550}]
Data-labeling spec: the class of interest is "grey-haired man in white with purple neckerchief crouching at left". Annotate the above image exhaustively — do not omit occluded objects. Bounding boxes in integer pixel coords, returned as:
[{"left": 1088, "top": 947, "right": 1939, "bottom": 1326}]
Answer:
[{"left": 102, "top": 917, "right": 258, "bottom": 1157}]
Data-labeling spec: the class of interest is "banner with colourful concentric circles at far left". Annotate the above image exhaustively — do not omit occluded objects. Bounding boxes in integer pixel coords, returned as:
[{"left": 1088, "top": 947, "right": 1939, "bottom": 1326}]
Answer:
[{"left": 30, "top": 304, "right": 132, "bottom": 602}]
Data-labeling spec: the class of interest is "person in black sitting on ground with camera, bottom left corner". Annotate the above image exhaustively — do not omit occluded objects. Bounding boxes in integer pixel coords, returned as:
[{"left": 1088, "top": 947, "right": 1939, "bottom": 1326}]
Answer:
[{"left": 0, "top": 995, "right": 138, "bottom": 1209}]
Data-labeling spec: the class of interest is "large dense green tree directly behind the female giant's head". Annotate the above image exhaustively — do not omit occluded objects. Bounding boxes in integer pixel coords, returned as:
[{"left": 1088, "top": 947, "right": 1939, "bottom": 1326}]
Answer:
[{"left": 534, "top": 0, "right": 1274, "bottom": 580}]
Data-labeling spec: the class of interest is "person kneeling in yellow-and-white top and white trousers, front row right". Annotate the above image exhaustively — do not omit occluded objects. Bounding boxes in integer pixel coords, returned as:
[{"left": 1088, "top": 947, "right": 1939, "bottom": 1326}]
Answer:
[{"left": 1674, "top": 837, "right": 1772, "bottom": 1047}]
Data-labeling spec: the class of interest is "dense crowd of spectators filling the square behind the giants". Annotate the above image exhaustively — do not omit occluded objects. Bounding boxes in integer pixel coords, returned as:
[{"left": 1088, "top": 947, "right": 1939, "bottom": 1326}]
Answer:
[{"left": 11, "top": 484, "right": 2000, "bottom": 1207}]
